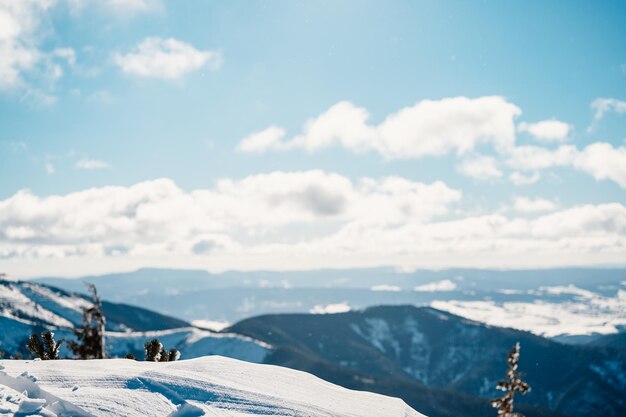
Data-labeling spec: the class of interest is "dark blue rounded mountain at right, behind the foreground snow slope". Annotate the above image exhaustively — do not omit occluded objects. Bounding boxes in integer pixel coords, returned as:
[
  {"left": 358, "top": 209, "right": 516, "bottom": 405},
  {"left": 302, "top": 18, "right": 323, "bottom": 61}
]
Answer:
[{"left": 228, "top": 306, "right": 626, "bottom": 417}]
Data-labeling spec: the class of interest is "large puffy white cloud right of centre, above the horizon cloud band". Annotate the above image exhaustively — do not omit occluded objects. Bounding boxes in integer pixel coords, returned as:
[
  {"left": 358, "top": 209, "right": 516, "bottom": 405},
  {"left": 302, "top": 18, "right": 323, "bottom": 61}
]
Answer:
[{"left": 240, "top": 96, "right": 521, "bottom": 159}]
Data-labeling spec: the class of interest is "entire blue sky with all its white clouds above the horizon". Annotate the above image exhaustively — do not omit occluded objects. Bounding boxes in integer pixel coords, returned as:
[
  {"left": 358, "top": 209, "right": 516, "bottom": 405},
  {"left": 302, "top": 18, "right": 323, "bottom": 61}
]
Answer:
[{"left": 0, "top": 0, "right": 626, "bottom": 277}]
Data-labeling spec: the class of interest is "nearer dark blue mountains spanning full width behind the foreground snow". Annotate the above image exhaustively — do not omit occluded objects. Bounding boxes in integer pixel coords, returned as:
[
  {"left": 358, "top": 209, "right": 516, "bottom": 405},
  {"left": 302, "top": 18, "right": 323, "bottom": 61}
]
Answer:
[{"left": 0, "top": 280, "right": 626, "bottom": 417}]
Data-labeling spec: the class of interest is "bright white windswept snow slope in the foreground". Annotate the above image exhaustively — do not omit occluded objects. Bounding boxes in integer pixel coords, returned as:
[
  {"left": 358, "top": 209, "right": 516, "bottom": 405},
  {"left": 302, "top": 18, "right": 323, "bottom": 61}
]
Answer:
[{"left": 0, "top": 356, "right": 423, "bottom": 417}]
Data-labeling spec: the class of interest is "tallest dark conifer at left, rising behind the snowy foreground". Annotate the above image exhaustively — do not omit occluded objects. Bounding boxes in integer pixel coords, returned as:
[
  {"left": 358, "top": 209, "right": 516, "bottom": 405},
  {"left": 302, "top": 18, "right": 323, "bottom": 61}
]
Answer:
[{"left": 68, "top": 284, "right": 106, "bottom": 359}]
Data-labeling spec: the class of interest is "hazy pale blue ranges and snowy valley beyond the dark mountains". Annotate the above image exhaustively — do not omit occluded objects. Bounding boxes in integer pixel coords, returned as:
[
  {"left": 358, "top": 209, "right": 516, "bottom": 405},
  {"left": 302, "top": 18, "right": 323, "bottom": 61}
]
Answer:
[{"left": 37, "top": 268, "right": 626, "bottom": 343}]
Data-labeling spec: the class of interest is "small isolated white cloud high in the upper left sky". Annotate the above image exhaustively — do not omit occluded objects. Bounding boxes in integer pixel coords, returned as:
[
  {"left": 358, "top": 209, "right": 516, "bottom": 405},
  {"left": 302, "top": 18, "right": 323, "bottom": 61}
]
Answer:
[{"left": 113, "top": 37, "right": 221, "bottom": 80}]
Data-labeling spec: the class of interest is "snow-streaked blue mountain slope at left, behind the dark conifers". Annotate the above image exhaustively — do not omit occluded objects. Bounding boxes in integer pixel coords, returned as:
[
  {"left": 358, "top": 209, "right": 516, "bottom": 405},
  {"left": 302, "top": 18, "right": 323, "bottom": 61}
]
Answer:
[{"left": 0, "top": 280, "right": 270, "bottom": 362}]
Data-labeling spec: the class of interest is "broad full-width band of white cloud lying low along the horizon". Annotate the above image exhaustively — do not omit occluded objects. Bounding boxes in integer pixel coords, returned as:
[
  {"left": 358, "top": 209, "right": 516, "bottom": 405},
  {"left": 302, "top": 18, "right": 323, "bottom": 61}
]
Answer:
[{"left": 0, "top": 171, "right": 626, "bottom": 276}]
